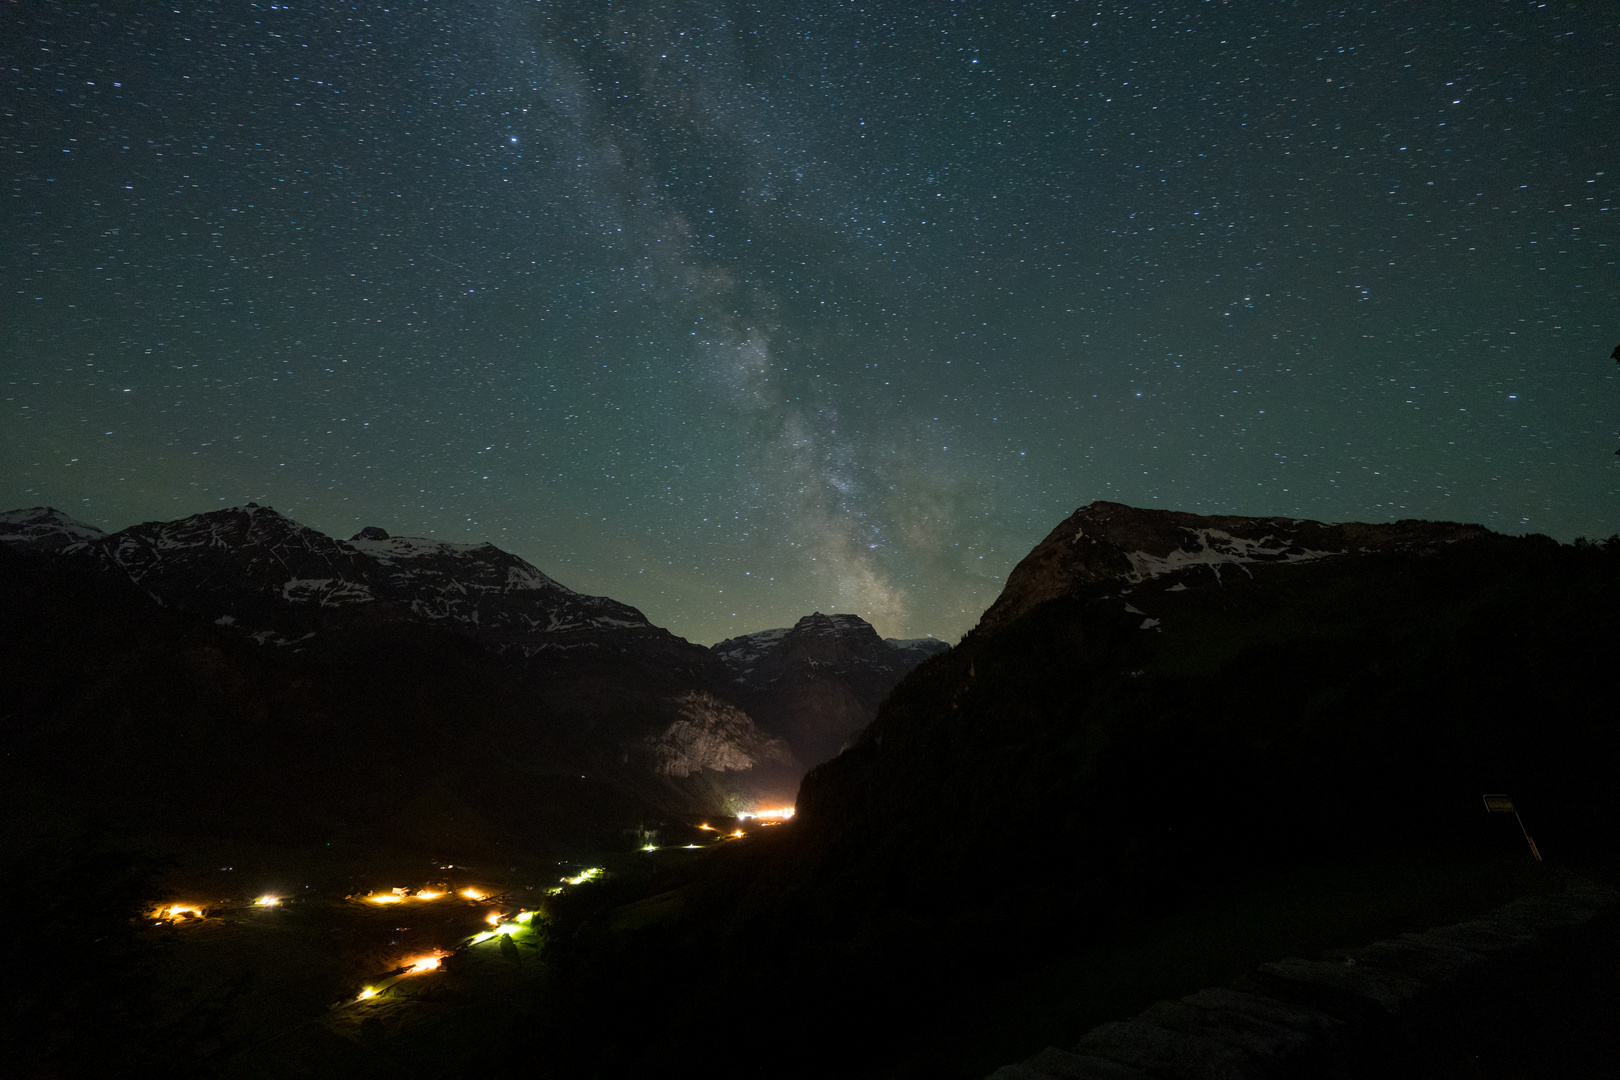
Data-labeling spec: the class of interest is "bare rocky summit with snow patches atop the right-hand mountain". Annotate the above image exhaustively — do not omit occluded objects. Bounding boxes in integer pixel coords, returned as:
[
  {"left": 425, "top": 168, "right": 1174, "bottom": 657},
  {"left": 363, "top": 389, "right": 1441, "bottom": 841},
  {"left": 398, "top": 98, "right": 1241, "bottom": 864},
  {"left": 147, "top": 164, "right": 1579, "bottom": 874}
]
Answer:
[{"left": 978, "top": 502, "right": 1489, "bottom": 633}]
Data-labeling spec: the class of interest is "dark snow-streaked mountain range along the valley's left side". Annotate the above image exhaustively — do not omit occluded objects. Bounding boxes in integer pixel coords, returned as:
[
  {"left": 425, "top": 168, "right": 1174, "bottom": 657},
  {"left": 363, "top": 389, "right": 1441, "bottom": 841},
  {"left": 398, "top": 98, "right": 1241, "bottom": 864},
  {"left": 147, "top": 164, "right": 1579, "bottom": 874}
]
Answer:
[{"left": 0, "top": 504, "right": 915, "bottom": 842}]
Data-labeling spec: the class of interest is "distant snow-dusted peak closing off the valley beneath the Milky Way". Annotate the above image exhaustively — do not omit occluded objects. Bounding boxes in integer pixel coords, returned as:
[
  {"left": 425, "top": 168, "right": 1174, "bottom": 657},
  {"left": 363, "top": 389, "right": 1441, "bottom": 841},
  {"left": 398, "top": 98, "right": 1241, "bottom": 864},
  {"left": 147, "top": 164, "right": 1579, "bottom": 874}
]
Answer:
[{"left": 713, "top": 612, "right": 949, "bottom": 766}]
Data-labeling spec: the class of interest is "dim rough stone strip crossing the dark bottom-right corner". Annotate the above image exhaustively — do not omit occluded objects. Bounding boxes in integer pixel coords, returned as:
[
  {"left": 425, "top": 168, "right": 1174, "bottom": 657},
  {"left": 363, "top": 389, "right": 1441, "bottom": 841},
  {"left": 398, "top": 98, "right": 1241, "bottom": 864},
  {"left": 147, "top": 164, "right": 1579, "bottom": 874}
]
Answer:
[{"left": 988, "top": 882, "right": 1615, "bottom": 1080}]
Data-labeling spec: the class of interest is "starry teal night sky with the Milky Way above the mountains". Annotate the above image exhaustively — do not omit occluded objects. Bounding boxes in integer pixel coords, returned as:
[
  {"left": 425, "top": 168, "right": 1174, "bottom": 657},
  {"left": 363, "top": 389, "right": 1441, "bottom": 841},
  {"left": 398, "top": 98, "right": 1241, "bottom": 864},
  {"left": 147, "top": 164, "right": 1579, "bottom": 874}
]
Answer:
[{"left": 0, "top": 0, "right": 1620, "bottom": 644}]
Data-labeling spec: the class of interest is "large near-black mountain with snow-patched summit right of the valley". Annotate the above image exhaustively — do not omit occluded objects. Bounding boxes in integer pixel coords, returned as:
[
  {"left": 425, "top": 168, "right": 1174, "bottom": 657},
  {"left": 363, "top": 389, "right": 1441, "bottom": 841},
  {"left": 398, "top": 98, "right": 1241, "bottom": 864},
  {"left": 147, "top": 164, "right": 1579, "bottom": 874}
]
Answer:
[{"left": 780, "top": 504, "right": 1620, "bottom": 1003}]
